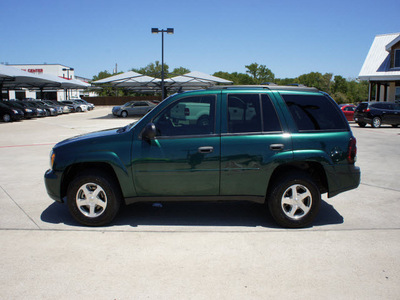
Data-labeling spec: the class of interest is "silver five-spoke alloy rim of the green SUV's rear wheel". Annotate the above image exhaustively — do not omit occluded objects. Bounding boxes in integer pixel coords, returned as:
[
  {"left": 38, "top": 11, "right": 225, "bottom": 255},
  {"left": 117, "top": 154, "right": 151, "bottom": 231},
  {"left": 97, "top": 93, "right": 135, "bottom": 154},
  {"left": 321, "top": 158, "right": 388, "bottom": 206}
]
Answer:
[{"left": 281, "top": 184, "right": 312, "bottom": 220}]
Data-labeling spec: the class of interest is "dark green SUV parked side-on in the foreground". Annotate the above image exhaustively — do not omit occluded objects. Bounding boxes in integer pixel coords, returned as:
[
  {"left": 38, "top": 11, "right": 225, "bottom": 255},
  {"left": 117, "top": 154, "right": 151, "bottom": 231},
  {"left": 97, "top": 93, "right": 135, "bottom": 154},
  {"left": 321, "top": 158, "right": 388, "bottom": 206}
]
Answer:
[{"left": 45, "top": 86, "right": 360, "bottom": 227}]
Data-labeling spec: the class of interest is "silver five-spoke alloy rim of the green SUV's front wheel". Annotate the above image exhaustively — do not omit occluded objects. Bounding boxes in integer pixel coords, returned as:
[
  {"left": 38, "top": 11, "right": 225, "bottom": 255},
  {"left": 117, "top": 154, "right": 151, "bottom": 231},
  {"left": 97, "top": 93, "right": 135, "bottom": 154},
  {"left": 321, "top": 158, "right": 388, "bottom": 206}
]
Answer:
[{"left": 76, "top": 183, "right": 107, "bottom": 218}]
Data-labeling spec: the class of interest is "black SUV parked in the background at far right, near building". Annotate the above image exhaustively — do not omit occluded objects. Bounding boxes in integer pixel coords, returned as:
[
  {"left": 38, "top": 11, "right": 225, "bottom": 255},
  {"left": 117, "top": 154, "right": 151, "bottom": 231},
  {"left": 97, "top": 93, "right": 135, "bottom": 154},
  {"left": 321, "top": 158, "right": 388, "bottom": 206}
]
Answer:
[{"left": 354, "top": 102, "right": 400, "bottom": 128}]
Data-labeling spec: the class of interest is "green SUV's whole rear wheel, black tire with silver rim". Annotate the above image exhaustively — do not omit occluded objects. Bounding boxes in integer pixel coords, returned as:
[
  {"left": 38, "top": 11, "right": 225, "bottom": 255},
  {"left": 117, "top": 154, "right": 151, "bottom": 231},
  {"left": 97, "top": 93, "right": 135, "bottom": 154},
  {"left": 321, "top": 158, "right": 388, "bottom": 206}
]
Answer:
[{"left": 267, "top": 172, "right": 321, "bottom": 228}]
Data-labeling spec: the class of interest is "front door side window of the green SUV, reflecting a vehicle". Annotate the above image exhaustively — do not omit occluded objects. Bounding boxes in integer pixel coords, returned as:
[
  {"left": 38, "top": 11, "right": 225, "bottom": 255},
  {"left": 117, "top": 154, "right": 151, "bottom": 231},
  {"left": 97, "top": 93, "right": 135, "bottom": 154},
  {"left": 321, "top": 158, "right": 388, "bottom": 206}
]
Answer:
[{"left": 153, "top": 95, "right": 216, "bottom": 137}]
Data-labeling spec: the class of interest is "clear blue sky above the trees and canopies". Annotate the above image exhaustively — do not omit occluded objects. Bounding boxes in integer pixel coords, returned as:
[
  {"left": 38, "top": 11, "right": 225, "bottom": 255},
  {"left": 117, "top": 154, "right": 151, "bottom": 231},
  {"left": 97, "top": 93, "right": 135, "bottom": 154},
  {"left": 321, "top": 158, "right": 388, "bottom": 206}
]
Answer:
[{"left": 0, "top": 0, "right": 400, "bottom": 78}]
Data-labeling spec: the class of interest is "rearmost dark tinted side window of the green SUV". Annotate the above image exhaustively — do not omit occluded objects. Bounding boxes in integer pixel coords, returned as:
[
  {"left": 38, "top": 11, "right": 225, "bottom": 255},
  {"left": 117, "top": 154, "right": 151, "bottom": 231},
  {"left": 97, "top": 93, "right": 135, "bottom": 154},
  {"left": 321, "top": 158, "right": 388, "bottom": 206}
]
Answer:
[{"left": 282, "top": 95, "right": 348, "bottom": 131}]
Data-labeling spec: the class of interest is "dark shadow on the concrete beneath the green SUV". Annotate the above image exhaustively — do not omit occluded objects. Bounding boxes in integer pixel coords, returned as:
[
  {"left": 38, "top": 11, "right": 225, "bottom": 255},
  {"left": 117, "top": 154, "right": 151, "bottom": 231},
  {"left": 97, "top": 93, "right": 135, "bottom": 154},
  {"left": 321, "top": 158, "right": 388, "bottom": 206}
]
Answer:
[{"left": 41, "top": 200, "right": 343, "bottom": 228}]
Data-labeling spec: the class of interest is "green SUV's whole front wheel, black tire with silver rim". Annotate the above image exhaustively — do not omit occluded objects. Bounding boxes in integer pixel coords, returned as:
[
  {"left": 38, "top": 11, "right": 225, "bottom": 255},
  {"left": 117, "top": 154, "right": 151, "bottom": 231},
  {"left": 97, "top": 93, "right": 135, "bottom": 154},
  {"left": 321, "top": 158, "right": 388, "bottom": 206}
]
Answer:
[{"left": 67, "top": 170, "right": 122, "bottom": 226}]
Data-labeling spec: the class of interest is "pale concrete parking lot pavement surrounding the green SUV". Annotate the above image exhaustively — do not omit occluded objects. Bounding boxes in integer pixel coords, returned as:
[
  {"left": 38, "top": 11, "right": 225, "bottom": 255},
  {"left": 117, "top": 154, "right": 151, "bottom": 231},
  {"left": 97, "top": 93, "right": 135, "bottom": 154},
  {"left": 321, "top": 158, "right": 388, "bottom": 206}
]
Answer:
[{"left": 0, "top": 107, "right": 400, "bottom": 299}]
